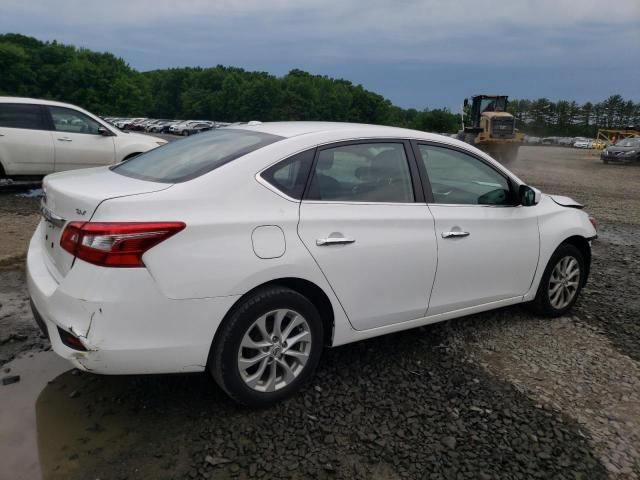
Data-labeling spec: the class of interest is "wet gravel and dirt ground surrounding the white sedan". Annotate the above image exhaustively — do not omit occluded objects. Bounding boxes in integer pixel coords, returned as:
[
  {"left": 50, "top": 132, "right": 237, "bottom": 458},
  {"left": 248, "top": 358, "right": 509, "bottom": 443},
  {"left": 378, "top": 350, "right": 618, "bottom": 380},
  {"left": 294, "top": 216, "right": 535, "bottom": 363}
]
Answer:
[{"left": 0, "top": 147, "right": 640, "bottom": 480}]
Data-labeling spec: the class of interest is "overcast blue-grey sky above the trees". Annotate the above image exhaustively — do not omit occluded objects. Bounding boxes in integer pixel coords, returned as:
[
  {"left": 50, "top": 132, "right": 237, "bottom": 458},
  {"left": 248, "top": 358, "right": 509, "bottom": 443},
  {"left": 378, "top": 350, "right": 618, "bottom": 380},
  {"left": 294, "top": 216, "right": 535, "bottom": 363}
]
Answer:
[{"left": 0, "top": 0, "right": 640, "bottom": 110}]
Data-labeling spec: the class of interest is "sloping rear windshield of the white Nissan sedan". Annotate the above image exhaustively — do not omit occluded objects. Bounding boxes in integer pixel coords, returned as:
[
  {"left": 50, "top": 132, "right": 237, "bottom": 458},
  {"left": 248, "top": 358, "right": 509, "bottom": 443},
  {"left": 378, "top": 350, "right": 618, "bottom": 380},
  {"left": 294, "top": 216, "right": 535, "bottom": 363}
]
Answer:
[{"left": 111, "top": 128, "right": 282, "bottom": 183}]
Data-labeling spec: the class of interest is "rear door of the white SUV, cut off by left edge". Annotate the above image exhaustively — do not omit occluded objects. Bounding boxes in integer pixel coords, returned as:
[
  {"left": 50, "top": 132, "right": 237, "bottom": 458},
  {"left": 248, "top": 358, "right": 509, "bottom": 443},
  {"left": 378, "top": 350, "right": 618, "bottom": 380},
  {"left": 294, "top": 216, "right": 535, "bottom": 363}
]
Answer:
[{"left": 0, "top": 103, "right": 54, "bottom": 175}]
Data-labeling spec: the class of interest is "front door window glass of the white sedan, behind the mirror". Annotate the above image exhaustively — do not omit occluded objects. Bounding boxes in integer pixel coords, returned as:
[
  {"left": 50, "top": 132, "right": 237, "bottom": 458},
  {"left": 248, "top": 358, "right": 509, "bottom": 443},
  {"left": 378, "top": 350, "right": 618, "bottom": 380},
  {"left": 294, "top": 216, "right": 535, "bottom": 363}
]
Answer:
[{"left": 419, "top": 145, "right": 515, "bottom": 205}]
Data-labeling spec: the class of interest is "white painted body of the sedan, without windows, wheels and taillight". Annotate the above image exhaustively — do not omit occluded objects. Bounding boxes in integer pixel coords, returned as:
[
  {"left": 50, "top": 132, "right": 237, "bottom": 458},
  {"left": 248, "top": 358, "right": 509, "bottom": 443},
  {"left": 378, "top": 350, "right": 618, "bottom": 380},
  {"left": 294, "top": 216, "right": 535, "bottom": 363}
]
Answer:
[{"left": 27, "top": 122, "right": 595, "bottom": 374}]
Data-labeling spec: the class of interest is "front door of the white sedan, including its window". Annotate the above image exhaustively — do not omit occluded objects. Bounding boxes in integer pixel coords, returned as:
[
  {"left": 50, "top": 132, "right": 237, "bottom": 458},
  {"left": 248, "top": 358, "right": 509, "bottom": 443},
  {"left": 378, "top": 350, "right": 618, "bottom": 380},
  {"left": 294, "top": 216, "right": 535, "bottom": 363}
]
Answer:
[{"left": 417, "top": 144, "right": 540, "bottom": 315}]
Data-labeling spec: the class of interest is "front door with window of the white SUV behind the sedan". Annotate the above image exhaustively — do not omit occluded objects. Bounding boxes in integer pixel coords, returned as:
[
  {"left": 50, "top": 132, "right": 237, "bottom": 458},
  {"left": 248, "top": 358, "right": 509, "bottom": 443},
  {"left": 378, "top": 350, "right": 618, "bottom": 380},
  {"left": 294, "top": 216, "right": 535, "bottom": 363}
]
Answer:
[{"left": 47, "top": 106, "right": 115, "bottom": 172}]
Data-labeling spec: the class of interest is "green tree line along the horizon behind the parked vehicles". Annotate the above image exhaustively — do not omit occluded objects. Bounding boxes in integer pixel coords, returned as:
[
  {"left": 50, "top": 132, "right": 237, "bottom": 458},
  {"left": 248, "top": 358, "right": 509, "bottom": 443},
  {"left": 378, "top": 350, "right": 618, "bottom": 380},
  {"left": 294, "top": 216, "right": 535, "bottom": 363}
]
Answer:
[{"left": 0, "top": 34, "right": 640, "bottom": 136}]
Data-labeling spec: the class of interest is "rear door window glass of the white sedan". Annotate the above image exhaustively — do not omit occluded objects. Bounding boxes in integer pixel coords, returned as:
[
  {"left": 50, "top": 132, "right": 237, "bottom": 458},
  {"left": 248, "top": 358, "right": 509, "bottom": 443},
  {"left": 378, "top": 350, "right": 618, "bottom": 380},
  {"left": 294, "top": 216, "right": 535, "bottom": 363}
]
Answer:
[{"left": 307, "top": 143, "right": 414, "bottom": 203}]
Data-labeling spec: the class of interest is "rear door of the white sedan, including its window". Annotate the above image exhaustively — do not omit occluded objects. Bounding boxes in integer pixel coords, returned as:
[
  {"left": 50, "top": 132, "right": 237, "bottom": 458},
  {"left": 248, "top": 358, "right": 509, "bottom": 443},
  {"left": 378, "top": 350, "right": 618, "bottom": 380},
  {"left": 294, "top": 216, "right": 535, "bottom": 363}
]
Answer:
[{"left": 298, "top": 139, "right": 437, "bottom": 330}]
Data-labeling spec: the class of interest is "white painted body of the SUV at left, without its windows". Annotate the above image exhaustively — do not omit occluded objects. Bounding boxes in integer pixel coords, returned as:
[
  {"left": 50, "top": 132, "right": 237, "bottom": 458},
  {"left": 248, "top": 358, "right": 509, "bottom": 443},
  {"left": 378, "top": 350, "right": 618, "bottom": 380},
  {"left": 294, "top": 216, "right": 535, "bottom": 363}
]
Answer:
[{"left": 0, "top": 97, "right": 167, "bottom": 176}]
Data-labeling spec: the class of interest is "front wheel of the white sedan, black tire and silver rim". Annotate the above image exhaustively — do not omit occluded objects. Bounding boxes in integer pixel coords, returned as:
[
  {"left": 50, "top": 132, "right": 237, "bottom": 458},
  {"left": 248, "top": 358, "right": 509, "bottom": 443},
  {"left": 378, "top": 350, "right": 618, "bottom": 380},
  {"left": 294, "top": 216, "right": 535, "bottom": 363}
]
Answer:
[{"left": 531, "top": 243, "right": 586, "bottom": 317}]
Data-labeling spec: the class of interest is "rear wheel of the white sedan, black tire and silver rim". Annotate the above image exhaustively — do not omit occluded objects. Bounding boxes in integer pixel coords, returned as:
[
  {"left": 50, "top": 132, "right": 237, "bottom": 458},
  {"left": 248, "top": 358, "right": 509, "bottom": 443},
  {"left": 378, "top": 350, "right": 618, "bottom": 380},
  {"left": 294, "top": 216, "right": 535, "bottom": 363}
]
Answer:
[{"left": 208, "top": 286, "right": 324, "bottom": 408}]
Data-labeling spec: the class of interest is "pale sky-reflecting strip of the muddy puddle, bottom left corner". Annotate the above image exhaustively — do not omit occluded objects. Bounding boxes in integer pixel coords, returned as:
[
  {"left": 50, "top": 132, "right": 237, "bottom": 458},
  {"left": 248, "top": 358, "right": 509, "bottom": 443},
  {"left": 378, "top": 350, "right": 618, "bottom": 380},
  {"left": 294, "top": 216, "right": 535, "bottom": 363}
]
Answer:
[{"left": 0, "top": 352, "right": 71, "bottom": 480}]
